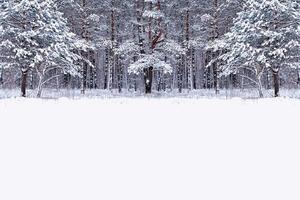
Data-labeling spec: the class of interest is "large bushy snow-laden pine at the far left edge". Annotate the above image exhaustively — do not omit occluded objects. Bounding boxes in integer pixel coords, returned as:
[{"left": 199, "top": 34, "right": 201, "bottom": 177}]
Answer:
[{"left": 0, "top": 0, "right": 87, "bottom": 96}]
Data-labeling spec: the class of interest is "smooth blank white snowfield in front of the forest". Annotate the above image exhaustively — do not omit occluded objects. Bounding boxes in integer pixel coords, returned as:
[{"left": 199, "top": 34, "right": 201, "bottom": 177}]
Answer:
[{"left": 0, "top": 97, "right": 300, "bottom": 200}]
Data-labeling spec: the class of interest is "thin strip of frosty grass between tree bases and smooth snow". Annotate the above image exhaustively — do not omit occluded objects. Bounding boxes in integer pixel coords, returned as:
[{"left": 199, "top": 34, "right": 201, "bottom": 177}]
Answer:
[{"left": 0, "top": 88, "right": 300, "bottom": 99}]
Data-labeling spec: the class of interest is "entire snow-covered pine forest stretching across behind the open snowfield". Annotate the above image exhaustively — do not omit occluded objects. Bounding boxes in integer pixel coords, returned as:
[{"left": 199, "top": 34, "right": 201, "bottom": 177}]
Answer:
[{"left": 0, "top": 0, "right": 300, "bottom": 97}]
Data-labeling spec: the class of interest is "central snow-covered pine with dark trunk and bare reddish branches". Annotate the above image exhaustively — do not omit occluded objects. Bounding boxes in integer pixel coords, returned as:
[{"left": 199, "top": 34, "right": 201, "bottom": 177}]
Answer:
[{"left": 118, "top": 0, "right": 185, "bottom": 93}]
